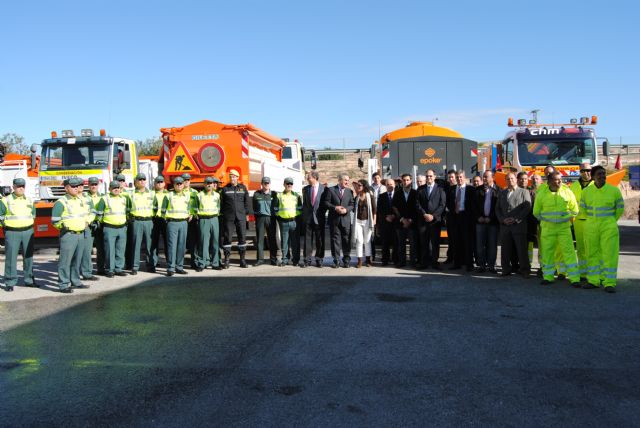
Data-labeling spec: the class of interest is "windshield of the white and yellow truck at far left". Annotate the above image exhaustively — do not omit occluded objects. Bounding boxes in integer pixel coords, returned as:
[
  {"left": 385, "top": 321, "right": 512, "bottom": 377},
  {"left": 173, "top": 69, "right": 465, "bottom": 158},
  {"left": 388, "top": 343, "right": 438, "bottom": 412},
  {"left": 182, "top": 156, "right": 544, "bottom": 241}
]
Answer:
[{"left": 40, "top": 144, "right": 109, "bottom": 171}]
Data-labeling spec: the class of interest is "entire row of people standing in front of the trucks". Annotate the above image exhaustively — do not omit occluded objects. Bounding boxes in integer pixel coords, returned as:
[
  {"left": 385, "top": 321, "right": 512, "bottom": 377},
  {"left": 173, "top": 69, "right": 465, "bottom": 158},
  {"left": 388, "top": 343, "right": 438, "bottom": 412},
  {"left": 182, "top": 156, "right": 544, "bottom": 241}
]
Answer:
[{"left": 0, "top": 164, "right": 624, "bottom": 293}]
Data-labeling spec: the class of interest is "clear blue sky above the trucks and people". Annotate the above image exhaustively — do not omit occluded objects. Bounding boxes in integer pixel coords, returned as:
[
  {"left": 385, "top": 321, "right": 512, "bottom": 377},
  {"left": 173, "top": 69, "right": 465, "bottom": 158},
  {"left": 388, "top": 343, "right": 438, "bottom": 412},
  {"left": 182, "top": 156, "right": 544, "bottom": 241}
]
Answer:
[{"left": 0, "top": 0, "right": 640, "bottom": 148}]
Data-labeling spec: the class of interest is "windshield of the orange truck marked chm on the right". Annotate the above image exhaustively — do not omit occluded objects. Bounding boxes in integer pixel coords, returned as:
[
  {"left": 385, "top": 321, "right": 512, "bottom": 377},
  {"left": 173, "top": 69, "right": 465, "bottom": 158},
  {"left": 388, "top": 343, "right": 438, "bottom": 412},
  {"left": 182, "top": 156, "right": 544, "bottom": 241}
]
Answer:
[{"left": 518, "top": 138, "right": 596, "bottom": 166}]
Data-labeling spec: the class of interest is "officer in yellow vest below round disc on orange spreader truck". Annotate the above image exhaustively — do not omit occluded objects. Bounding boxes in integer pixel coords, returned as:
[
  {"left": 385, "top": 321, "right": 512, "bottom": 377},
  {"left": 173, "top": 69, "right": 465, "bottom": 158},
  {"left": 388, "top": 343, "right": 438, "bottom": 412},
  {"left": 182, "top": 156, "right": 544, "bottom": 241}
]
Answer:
[{"left": 196, "top": 177, "right": 221, "bottom": 272}]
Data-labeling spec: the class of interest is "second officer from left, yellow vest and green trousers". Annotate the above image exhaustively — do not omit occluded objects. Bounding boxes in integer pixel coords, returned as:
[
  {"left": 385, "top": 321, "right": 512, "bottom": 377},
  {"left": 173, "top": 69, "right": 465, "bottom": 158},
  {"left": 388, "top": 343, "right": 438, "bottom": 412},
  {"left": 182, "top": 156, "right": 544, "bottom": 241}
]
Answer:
[{"left": 51, "top": 177, "right": 89, "bottom": 293}]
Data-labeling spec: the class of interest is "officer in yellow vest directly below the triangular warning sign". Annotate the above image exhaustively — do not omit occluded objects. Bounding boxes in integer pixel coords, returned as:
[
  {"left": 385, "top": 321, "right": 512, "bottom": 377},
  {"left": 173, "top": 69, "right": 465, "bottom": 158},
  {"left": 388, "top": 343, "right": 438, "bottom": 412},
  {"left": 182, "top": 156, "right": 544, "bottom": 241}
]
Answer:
[{"left": 161, "top": 177, "right": 192, "bottom": 276}]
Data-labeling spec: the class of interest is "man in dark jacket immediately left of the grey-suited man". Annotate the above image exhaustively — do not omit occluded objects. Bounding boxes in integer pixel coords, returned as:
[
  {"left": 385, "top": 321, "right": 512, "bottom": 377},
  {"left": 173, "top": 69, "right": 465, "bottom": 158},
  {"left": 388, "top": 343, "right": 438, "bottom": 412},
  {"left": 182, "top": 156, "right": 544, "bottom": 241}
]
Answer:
[{"left": 473, "top": 171, "right": 499, "bottom": 273}]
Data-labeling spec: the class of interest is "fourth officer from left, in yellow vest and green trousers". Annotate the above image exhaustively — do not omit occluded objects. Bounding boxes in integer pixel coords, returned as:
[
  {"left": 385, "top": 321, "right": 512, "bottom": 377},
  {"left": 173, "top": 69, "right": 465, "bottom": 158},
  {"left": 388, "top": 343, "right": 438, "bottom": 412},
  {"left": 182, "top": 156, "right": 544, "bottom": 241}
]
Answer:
[{"left": 96, "top": 180, "right": 131, "bottom": 278}]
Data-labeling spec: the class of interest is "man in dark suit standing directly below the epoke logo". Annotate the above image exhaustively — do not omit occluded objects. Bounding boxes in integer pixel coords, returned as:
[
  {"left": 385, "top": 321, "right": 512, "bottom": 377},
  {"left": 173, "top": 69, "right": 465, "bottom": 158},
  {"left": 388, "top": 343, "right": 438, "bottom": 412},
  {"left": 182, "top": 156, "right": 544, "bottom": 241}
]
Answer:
[{"left": 417, "top": 169, "right": 446, "bottom": 270}]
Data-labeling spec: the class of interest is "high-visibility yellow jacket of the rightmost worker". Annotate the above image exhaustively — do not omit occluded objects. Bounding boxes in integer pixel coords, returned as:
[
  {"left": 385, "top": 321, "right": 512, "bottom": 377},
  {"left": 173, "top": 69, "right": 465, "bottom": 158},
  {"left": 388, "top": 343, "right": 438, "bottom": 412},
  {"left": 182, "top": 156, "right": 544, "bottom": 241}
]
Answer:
[{"left": 580, "top": 183, "right": 624, "bottom": 222}]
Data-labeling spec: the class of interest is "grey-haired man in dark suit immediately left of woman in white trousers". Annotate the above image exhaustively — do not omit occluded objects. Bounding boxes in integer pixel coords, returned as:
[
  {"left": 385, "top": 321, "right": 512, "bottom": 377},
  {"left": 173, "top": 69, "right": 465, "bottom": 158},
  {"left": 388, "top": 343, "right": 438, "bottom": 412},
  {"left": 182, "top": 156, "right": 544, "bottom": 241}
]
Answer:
[{"left": 323, "top": 173, "right": 354, "bottom": 268}]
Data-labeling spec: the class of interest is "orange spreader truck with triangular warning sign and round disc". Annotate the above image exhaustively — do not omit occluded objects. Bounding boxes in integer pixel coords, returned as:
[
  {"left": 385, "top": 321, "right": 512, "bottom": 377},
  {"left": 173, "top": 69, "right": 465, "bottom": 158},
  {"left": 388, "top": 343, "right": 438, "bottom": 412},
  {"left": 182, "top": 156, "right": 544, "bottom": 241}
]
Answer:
[{"left": 158, "top": 120, "right": 304, "bottom": 195}]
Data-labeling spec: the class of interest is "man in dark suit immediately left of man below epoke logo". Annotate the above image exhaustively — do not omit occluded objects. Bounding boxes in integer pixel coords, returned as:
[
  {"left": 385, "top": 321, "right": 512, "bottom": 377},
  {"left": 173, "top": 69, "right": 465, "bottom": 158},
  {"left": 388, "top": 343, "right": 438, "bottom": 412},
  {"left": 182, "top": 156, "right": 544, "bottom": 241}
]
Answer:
[{"left": 392, "top": 174, "right": 418, "bottom": 267}]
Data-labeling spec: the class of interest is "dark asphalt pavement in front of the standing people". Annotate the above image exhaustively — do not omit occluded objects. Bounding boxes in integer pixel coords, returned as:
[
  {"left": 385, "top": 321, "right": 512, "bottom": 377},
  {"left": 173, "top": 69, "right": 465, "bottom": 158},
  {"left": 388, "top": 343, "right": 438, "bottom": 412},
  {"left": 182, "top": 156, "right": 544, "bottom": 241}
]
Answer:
[{"left": 0, "top": 222, "right": 640, "bottom": 427}]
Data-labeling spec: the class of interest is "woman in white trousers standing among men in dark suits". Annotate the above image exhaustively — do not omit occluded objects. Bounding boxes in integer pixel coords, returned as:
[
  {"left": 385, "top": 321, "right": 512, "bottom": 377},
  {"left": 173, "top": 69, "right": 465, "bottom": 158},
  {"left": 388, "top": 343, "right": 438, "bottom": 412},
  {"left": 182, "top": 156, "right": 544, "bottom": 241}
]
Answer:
[{"left": 351, "top": 180, "right": 376, "bottom": 268}]
